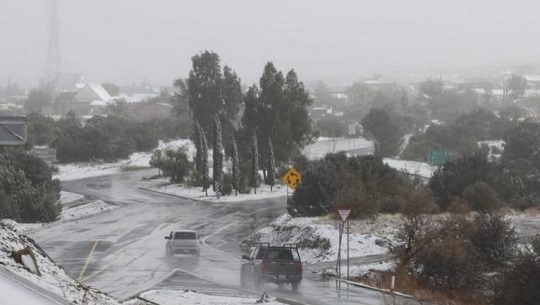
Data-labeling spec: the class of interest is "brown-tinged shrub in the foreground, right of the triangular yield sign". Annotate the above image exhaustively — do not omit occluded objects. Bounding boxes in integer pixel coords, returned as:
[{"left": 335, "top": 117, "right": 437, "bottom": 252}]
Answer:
[{"left": 390, "top": 214, "right": 516, "bottom": 298}]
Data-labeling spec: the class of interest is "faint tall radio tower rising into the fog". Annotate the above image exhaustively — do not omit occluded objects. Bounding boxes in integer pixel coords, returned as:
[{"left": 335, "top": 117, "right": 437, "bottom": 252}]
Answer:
[{"left": 44, "top": 0, "right": 61, "bottom": 88}]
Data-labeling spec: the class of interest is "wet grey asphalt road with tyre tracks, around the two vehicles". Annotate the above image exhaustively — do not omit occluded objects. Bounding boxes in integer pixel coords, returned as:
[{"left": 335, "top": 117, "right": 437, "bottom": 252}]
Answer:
[{"left": 28, "top": 170, "right": 426, "bottom": 305}]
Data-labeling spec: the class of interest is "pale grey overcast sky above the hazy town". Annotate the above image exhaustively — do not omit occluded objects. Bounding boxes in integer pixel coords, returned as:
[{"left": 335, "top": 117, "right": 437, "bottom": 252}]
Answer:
[{"left": 0, "top": 0, "right": 540, "bottom": 86}]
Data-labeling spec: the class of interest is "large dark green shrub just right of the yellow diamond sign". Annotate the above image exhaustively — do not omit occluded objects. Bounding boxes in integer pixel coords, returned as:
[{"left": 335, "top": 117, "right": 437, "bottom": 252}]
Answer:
[{"left": 287, "top": 152, "right": 417, "bottom": 218}]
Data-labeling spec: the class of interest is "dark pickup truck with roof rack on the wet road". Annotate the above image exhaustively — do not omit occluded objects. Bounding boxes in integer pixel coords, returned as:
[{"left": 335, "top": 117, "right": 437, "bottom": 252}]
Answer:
[{"left": 240, "top": 243, "right": 303, "bottom": 291}]
